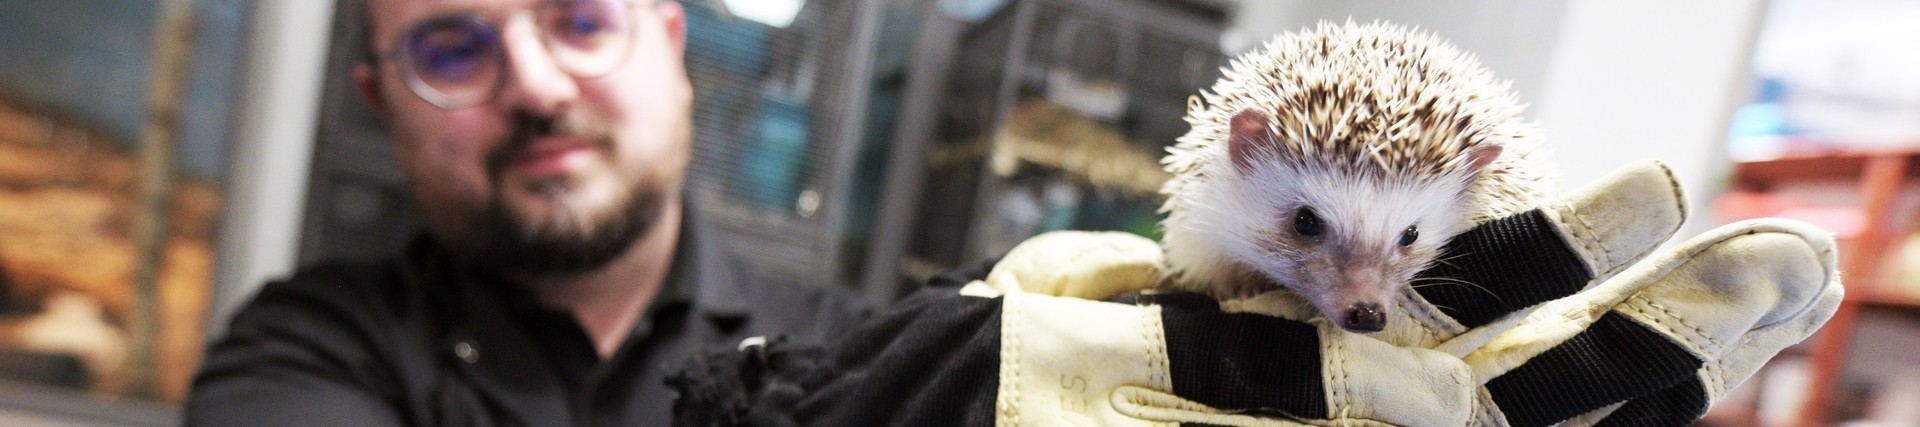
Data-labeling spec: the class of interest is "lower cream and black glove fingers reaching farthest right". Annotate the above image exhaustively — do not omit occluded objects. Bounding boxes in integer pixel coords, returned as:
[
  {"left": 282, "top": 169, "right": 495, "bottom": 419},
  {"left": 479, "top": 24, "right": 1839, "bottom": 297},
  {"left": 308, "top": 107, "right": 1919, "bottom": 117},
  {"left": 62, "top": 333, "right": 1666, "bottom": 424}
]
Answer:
[{"left": 1450, "top": 219, "right": 1841, "bottom": 425}]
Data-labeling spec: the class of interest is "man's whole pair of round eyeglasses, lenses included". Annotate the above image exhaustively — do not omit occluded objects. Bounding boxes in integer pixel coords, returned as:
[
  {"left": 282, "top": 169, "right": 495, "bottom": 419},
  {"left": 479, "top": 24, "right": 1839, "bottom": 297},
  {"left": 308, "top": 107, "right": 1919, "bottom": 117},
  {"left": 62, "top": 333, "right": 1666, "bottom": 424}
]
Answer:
[{"left": 380, "top": 0, "right": 637, "bottom": 110}]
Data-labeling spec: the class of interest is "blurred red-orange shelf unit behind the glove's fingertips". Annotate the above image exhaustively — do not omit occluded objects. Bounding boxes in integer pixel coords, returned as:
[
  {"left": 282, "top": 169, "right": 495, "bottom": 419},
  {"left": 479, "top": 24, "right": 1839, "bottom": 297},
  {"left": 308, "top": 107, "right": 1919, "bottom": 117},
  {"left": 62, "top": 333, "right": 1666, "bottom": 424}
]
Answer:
[{"left": 1703, "top": 148, "right": 1920, "bottom": 425}]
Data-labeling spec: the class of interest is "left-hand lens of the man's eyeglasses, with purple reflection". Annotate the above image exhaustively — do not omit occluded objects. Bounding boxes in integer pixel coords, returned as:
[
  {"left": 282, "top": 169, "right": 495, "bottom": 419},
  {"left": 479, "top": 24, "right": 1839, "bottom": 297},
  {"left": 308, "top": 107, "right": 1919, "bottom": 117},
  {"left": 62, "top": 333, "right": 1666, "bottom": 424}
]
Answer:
[{"left": 403, "top": 17, "right": 503, "bottom": 106}]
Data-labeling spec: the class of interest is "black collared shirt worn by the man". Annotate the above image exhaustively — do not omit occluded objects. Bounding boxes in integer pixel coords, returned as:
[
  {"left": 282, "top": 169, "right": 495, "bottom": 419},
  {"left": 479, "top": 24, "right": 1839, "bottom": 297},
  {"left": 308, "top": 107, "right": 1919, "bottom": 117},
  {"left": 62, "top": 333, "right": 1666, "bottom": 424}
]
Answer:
[{"left": 186, "top": 210, "right": 864, "bottom": 425}]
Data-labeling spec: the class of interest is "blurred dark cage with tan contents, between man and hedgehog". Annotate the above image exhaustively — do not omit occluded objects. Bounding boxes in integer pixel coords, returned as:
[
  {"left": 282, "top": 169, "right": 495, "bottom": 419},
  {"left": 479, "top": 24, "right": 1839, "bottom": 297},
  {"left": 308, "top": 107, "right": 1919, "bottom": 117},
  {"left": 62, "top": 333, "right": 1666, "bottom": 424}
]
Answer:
[{"left": 879, "top": 0, "right": 1227, "bottom": 283}]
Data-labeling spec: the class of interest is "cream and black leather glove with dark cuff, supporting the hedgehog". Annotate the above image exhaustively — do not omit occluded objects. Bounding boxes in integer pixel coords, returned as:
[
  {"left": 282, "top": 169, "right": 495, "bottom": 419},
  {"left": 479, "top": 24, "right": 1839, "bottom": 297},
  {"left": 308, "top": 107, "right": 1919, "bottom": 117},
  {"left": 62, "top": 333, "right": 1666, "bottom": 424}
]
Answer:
[{"left": 685, "top": 163, "right": 1841, "bottom": 425}]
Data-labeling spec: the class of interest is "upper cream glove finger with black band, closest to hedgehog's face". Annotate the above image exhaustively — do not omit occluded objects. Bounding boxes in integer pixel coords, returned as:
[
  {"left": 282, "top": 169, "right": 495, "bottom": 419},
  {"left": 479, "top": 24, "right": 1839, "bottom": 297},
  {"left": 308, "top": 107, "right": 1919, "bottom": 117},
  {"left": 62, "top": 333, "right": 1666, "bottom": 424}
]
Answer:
[{"left": 1407, "top": 162, "right": 1686, "bottom": 332}]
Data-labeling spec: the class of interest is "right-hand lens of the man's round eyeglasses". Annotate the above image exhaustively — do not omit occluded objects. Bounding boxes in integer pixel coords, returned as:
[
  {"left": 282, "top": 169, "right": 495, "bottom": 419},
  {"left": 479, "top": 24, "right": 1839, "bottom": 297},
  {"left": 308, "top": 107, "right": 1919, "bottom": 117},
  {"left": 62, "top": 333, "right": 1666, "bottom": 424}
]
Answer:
[{"left": 540, "top": 0, "right": 634, "bottom": 77}]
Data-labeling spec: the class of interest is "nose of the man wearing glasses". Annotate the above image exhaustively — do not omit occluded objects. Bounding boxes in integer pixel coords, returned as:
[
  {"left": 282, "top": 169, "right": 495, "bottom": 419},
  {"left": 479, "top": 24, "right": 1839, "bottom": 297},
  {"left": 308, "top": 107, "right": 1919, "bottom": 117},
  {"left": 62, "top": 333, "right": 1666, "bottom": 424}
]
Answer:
[{"left": 499, "top": 21, "right": 580, "bottom": 115}]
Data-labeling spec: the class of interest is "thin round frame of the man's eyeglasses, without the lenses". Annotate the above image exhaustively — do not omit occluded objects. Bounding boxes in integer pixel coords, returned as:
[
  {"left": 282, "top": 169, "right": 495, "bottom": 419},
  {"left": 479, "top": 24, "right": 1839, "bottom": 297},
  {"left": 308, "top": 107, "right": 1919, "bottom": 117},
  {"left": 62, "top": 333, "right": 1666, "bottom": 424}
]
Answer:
[{"left": 374, "top": 0, "right": 639, "bottom": 110}]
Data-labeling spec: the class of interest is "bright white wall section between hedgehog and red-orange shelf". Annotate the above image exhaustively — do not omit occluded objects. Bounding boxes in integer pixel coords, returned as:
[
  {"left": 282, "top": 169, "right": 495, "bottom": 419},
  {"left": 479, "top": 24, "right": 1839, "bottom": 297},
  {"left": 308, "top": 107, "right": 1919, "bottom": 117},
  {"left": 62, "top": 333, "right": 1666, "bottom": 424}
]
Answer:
[{"left": 1534, "top": 0, "right": 1766, "bottom": 235}]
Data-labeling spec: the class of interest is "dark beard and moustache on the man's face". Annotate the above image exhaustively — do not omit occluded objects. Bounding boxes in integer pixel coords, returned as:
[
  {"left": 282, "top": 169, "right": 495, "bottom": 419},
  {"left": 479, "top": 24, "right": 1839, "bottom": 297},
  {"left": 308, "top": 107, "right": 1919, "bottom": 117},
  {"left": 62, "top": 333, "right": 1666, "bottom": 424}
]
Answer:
[{"left": 465, "top": 113, "right": 666, "bottom": 279}]
